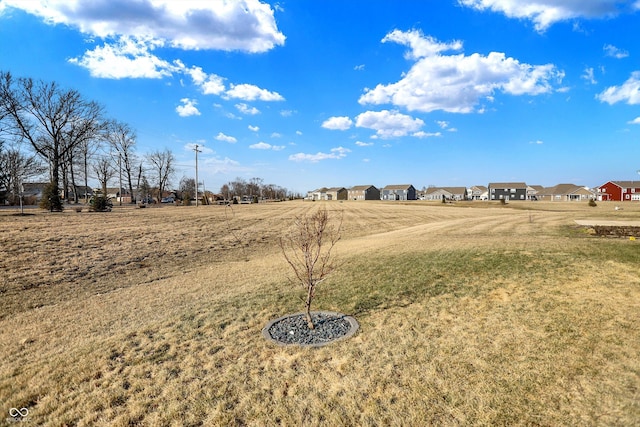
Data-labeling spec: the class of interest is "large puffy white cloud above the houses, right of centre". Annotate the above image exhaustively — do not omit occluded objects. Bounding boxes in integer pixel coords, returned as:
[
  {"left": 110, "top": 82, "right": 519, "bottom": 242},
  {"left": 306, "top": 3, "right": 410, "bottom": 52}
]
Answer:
[{"left": 358, "top": 30, "right": 564, "bottom": 113}]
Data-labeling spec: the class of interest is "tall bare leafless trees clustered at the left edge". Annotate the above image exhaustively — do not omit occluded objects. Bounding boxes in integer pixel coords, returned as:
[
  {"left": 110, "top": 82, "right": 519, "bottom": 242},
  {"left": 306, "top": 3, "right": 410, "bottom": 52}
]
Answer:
[{"left": 0, "top": 71, "right": 181, "bottom": 210}]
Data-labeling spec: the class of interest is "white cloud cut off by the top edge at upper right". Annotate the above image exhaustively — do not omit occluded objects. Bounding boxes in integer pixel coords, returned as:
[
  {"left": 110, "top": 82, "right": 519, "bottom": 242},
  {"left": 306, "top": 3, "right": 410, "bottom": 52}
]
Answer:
[{"left": 458, "top": 0, "right": 629, "bottom": 32}]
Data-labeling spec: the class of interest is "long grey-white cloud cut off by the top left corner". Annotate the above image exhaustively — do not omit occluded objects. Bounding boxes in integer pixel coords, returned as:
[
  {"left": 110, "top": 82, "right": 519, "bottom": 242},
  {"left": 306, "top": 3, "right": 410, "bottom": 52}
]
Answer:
[{"left": 2, "top": 0, "right": 285, "bottom": 52}]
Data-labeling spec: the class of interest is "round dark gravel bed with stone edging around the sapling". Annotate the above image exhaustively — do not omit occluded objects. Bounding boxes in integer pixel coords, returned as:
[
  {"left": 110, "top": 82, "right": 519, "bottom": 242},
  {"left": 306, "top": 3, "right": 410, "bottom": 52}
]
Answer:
[{"left": 262, "top": 311, "right": 359, "bottom": 347}]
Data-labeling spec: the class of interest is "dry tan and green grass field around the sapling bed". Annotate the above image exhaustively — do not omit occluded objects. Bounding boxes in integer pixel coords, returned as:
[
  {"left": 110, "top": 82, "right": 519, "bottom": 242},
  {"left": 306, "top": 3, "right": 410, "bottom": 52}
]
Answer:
[{"left": 0, "top": 202, "right": 640, "bottom": 426}]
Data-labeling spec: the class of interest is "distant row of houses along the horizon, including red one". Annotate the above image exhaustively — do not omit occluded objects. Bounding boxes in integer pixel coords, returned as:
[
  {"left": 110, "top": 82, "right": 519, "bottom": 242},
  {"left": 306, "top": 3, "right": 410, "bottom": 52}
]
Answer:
[{"left": 305, "top": 181, "right": 640, "bottom": 202}]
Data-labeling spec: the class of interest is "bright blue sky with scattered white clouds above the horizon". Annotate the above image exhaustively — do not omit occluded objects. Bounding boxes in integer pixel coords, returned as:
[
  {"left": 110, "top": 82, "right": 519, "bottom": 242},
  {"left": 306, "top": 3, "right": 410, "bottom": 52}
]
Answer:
[{"left": 0, "top": 0, "right": 640, "bottom": 192}]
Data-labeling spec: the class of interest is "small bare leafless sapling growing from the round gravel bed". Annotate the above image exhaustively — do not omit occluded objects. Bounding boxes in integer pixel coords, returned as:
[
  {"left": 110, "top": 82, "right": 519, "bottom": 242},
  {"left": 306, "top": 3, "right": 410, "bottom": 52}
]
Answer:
[{"left": 280, "top": 208, "right": 342, "bottom": 329}]
